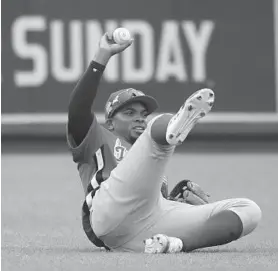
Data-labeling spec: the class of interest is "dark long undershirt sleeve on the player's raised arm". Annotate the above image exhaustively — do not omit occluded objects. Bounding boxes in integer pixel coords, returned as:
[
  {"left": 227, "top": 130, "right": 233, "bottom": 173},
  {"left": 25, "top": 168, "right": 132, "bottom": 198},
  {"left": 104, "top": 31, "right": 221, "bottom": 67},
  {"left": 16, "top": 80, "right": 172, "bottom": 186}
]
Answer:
[{"left": 68, "top": 61, "right": 105, "bottom": 146}]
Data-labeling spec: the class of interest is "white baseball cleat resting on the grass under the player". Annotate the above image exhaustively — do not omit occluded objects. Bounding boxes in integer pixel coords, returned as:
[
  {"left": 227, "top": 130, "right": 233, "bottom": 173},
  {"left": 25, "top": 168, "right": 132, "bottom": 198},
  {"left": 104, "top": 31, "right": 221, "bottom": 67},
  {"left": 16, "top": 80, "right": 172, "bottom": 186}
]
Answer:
[{"left": 144, "top": 234, "right": 183, "bottom": 254}]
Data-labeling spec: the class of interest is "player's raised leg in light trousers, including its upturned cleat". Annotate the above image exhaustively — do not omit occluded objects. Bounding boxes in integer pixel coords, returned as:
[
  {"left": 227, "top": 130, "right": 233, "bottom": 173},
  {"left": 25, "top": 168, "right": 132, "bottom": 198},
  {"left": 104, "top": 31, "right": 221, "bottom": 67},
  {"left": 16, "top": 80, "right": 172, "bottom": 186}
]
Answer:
[{"left": 92, "top": 89, "right": 214, "bottom": 246}]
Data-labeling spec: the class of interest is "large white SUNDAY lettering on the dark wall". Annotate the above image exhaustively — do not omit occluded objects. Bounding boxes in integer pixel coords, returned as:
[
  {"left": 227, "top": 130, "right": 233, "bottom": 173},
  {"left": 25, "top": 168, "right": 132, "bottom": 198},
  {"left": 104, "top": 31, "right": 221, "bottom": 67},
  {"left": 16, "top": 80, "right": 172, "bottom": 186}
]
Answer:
[{"left": 11, "top": 16, "right": 215, "bottom": 87}]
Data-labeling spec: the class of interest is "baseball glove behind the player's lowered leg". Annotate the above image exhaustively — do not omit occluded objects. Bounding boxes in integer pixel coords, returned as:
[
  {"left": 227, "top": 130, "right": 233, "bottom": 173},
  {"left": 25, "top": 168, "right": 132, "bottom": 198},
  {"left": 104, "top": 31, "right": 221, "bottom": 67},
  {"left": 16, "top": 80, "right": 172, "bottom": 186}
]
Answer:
[{"left": 168, "top": 180, "right": 209, "bottom": 205}]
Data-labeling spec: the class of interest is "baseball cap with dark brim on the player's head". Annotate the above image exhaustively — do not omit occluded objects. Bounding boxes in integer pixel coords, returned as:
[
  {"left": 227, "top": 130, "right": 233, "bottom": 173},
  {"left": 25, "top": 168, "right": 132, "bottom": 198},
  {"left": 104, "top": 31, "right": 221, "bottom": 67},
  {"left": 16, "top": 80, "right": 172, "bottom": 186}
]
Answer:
[{"left": 105, "top": 88, "right": 158, "bottom": 119}]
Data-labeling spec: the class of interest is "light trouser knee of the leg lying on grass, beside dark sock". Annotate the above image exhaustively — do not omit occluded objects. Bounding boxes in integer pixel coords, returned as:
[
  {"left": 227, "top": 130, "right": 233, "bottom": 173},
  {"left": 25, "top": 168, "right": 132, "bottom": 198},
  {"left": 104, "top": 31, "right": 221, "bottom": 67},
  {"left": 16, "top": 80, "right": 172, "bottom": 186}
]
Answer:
[{"left": 231, "top": 199, "right": 262, "bottom": 239}]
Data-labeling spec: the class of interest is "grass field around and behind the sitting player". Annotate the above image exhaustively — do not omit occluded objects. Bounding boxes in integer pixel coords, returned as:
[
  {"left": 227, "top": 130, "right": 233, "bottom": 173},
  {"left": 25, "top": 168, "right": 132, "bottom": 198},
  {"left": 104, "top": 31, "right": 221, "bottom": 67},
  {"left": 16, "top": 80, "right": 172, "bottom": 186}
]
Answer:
[{"left": 1, "top": 139, "right": 278, "bottom": 271}]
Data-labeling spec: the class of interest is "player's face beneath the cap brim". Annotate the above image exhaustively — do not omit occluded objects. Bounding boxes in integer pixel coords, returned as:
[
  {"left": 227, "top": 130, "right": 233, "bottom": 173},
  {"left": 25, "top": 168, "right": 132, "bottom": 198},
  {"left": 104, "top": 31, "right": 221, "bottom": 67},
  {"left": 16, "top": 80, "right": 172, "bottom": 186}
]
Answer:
[{"left": 112, "top": 102, "right": 148, "bottom": 144}]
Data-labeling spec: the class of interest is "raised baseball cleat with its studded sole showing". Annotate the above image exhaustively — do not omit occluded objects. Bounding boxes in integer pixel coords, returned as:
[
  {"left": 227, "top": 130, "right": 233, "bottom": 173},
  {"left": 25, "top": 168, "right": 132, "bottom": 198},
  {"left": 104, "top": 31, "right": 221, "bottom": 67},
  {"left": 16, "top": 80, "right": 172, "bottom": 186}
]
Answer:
[{"left": 166, "top": 88, "right": 214, "bottom": 145}]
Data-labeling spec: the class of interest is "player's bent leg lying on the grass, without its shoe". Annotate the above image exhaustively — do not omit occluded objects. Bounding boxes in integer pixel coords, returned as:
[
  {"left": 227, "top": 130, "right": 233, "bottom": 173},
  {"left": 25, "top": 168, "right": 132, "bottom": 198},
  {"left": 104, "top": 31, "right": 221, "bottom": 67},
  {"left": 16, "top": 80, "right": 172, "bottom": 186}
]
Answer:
[{"left": 121, "top": 198, "right": 261, "bottom": 251}]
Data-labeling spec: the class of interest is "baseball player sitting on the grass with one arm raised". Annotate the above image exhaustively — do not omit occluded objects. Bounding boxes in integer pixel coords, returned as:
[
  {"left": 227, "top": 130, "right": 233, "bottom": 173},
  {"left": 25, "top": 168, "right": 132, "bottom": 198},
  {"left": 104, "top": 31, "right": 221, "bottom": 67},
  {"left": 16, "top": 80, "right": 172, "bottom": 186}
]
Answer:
[{"left": 67, "top": 33, "right": 261, "bottom": 253}]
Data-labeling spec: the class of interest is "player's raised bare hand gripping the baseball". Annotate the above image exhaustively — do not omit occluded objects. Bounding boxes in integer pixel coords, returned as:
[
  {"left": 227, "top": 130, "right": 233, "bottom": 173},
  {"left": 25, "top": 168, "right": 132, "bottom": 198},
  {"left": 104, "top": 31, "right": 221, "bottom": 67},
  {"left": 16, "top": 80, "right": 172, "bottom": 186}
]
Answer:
[{"left": 93, "top": 33, "right": 133, "bottom": 66}]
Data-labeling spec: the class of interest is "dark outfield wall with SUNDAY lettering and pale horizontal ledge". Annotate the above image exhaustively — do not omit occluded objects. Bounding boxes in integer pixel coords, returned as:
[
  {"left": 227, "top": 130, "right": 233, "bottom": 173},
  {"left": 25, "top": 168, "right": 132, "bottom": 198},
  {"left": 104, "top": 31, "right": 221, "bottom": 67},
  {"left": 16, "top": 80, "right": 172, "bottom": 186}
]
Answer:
[{"left": 2, "top": 0, "right": 278, "bottom": 136}]
